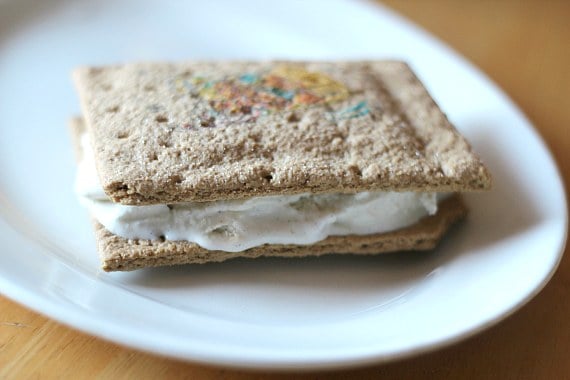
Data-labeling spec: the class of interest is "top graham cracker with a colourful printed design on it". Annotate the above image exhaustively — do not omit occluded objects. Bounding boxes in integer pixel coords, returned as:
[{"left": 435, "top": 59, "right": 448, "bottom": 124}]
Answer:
[{"left": 74, "top": 61, "right": 491, "bottom": 205}]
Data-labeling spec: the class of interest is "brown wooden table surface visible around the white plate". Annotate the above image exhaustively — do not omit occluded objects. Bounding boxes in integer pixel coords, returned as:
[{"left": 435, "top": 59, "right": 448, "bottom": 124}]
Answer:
[{"left": 0, "top": 0, "right": 570, "bottom": 379}]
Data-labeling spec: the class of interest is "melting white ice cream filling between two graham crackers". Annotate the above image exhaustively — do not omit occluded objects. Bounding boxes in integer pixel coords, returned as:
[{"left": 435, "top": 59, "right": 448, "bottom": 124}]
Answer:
[{"left": 76, "top": 134, "right": 438, "bottom": 252}]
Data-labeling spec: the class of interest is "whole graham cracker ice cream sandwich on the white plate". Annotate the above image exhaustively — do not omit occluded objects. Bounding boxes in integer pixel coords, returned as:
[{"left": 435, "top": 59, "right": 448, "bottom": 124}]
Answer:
[{"left": 71, "top": 61, "right": 491, "bottom": 271}]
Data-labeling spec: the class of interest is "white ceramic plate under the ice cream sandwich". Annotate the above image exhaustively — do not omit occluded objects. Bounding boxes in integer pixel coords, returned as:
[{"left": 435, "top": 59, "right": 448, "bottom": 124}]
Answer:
[{"left": 0, "top": 0, "right": 567, "bottom": 368}]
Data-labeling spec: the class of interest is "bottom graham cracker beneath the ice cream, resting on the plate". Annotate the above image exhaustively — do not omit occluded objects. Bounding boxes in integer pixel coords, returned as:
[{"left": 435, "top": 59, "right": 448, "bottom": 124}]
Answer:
[{"left": 94, "top": 195, "right": 467, "bottom": 272}]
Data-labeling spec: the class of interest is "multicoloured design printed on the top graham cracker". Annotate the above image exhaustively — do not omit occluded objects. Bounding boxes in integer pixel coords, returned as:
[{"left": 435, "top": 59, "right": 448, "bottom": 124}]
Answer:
[{"left": 176, "top": 65, "right": 369, "bottom": 125}]
